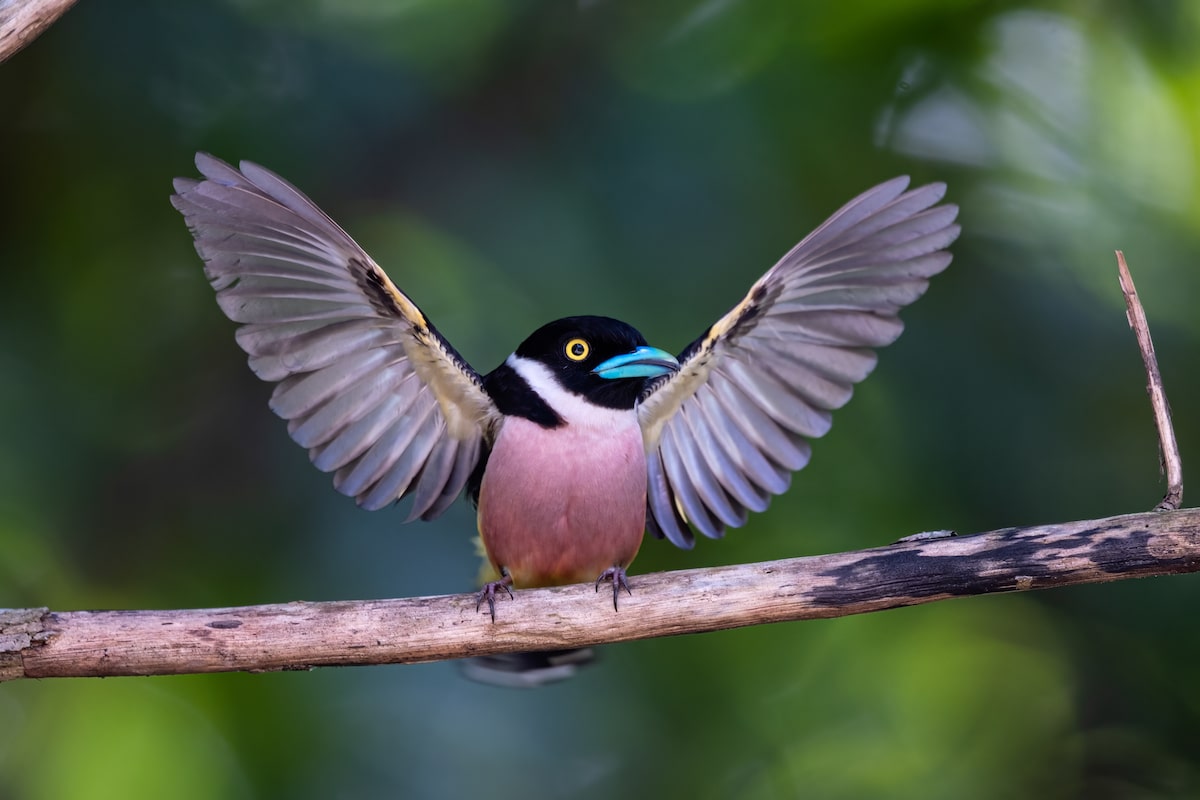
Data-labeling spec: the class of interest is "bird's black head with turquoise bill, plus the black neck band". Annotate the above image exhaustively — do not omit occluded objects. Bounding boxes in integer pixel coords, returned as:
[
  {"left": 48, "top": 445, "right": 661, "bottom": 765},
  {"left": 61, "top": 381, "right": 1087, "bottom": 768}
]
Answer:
[{"left": 485, "top": 317, "right": 678, "bottom": 426}]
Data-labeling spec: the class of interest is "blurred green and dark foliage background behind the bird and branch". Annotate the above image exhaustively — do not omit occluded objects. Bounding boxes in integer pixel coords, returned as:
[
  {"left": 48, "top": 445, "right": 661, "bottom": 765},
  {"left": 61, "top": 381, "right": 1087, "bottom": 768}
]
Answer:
[{"left": 0, "top": 0, "right": 1200, "bottom": 800}]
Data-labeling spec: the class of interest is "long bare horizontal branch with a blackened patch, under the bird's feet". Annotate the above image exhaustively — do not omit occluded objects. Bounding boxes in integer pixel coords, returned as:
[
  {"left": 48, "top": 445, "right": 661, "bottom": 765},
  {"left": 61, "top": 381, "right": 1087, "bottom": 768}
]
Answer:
[{"left": 0, "top": 509, "right": 1200, "bottom": 680}]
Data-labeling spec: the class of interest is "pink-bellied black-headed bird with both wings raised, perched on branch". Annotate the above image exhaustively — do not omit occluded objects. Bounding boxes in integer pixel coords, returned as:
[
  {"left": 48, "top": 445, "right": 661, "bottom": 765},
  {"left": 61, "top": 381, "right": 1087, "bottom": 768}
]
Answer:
[{"left": 170, "top": 152, "right": 960, "bottom": 686}]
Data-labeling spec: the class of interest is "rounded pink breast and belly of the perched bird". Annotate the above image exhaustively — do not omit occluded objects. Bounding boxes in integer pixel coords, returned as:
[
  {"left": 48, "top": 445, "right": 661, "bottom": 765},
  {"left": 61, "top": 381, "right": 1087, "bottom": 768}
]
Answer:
[{"left": 479, "top": 414, "right": 646, "bottom": 587}]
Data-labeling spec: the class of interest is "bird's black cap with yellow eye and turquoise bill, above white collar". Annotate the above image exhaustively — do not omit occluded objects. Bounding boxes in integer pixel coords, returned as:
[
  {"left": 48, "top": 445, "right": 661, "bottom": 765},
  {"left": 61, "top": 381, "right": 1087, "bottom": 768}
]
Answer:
[{"left": 514, "top": 317, "right": 679, "bottom": 409}]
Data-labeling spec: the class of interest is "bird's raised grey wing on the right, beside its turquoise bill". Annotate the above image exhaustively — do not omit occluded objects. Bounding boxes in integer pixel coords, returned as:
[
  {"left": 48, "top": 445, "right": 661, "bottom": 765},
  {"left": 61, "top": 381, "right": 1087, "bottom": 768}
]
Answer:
[{"left": 638, "top": 178, "right": 959, "bottom": 548}]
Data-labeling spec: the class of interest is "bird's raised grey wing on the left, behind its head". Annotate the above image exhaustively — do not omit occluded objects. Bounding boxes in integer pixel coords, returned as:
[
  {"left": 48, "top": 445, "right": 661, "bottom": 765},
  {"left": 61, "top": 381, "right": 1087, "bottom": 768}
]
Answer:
[{"left": 172, "top": 154, "right": 497, "bottom": 519}]
